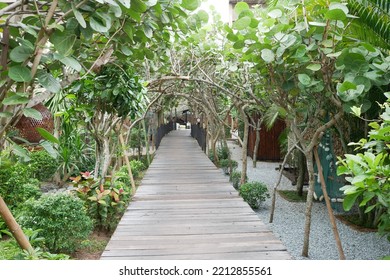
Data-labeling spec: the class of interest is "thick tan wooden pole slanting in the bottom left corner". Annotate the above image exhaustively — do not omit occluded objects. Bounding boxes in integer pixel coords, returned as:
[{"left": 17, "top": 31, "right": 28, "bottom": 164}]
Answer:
[{"left": 0, "top": 196, "right": 34, "bottom": 252}]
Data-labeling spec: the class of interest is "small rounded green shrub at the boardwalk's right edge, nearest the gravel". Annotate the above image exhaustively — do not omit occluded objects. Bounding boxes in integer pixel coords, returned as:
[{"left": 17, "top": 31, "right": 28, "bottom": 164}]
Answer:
[{"left": 239, "top": 182, "right": 270, "bottom": 209}]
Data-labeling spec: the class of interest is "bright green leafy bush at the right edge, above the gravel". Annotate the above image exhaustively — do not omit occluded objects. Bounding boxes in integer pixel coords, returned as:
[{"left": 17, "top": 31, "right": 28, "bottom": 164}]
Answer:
[{"left": 337, "top": 93, "right": 390, "bottom": 241}]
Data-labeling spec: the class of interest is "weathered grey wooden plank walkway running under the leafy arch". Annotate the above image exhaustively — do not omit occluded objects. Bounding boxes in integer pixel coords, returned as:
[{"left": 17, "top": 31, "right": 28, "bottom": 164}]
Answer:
[{"left": 101, "top": 130, "right": 291, "bottom": 260}]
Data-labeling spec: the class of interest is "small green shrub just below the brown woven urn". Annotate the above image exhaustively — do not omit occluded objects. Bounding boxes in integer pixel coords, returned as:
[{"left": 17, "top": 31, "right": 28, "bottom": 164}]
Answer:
[{"left": 29, "top": 150, "right": 59, "bottom": 181}]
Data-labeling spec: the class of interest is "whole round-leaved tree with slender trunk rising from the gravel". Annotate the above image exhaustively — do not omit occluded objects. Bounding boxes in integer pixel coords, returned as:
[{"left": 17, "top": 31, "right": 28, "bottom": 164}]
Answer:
[{"left": 229, "top": 1, "right": 388, "bottom": 256}]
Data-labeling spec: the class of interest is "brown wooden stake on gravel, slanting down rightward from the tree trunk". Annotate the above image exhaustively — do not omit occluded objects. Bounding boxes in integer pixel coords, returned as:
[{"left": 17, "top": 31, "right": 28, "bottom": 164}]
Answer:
[{"left": 314, "top": 147, "right": 345, "bottom": 260}]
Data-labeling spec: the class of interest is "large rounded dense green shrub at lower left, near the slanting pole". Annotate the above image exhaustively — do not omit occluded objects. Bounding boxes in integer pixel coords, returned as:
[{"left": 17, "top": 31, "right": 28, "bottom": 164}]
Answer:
[{"left": 18, "top": 194, "right": 93, "bottom": 253}]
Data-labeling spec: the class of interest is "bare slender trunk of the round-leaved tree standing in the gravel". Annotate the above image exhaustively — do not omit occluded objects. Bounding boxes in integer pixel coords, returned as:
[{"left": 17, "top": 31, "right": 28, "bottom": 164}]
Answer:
[{"left": 302, "top": 150, "right": 315, "bottom": 257}]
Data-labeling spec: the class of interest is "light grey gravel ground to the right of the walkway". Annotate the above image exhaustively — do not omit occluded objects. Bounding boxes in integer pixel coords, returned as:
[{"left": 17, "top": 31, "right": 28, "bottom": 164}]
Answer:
[{"left": 225, "top": 142, "right": 390, "bottom": 260}]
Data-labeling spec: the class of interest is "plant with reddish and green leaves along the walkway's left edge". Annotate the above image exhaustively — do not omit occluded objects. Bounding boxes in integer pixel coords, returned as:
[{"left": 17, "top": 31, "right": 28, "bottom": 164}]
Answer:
[{"left": 71, "top": 172, "right": 130, "bottom": 231}]
